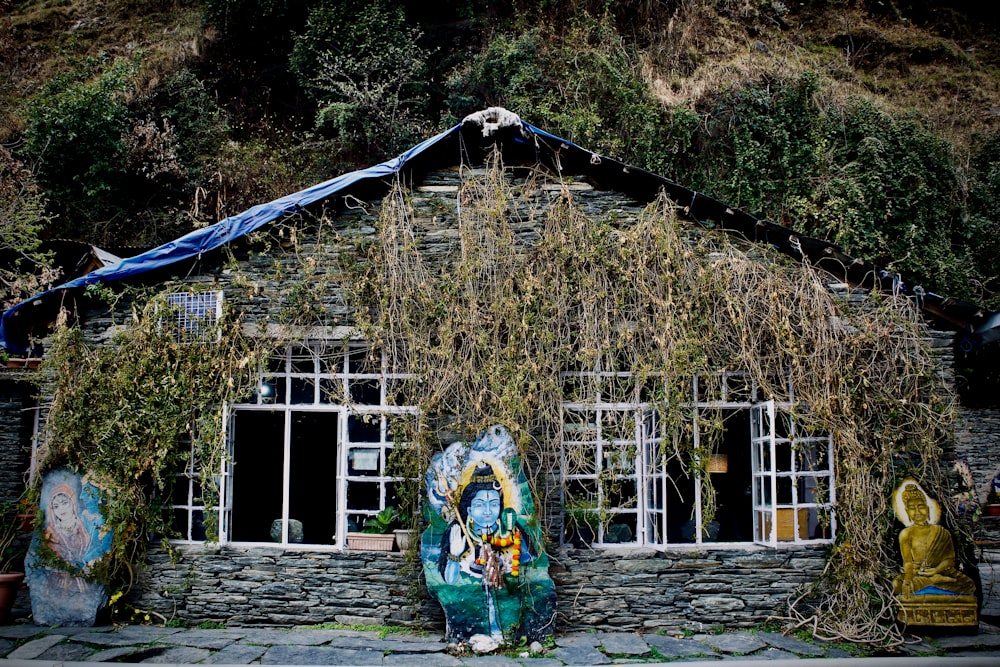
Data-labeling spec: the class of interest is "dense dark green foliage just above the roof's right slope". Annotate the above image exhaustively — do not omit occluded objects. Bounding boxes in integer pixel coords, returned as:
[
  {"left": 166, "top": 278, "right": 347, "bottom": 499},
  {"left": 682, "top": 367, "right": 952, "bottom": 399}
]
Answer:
[{"left": 691, "top": 73, "right": 982, "bottom": 297}]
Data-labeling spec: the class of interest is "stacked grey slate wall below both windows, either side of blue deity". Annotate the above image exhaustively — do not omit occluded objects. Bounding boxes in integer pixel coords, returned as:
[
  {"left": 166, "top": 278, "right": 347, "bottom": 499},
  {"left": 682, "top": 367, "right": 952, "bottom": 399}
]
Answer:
[{"left": 133, "top": 545, "right": 825, "bottom": 631}]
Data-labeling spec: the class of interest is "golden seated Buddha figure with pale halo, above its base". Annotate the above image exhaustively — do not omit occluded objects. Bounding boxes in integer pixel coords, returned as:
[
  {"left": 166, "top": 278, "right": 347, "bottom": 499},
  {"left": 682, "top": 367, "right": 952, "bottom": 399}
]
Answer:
[{"left": 893, "top": 479, "right": 976, "bottom": 599}]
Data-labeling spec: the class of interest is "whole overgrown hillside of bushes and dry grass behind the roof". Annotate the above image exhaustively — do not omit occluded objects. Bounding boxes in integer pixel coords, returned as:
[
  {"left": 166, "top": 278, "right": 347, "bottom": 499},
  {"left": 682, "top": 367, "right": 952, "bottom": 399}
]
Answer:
[{"left": 0, "top": 0, "right": 1000, "bottom": 309}]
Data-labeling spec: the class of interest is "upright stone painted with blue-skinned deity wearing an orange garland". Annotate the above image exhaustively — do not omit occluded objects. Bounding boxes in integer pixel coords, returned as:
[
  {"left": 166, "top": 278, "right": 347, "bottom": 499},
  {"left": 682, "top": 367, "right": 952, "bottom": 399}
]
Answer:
[{"left": 420, "top": 426, "right": 556, "bottom": 650}]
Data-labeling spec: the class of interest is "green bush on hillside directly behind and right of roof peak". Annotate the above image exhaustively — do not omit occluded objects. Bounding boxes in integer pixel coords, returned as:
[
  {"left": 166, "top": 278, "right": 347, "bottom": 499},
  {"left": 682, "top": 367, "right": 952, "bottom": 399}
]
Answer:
[{"left": 446, "top": 12, "right": 699, "bottom": 178}]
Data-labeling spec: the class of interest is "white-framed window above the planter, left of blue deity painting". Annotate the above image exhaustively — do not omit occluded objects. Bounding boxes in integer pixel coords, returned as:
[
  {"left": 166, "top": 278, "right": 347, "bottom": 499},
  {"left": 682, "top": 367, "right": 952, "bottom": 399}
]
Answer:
[{"left": 176, "top": 340, "right": 417, "bottom": 550}]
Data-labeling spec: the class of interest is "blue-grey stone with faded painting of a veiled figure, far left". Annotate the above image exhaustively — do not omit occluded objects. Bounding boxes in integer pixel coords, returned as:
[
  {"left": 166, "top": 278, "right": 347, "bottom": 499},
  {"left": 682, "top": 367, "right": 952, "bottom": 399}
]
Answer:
[{"left": 25, "top": 469, "right": 113, "bottom": 626}]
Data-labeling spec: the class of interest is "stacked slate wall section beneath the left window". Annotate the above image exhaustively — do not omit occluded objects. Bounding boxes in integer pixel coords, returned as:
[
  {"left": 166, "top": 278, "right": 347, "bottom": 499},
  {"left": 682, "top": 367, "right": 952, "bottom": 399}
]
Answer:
[{"left": 134, "top": 544, "right": 443, "bottom": 627}]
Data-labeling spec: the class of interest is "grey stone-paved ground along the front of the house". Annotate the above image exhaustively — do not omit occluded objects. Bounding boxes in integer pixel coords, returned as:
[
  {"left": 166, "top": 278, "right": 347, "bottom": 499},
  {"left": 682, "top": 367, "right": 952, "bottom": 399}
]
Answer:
[{"left": 0, "top": 624, "right": 1000, "bottom": 667}]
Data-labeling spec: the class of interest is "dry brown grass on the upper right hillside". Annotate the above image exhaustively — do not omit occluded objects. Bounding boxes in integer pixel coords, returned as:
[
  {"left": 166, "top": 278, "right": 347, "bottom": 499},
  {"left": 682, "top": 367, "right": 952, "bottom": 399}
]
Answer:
[{"left": 642, "top": 2, "right": 1000, "bottom": 147}]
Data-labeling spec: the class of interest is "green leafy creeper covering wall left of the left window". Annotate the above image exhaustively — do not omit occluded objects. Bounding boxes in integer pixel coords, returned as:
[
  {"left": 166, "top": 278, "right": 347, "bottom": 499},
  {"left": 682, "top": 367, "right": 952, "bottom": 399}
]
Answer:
[{"left": 33, "top": 285, "right": 264, "bottom": 599}]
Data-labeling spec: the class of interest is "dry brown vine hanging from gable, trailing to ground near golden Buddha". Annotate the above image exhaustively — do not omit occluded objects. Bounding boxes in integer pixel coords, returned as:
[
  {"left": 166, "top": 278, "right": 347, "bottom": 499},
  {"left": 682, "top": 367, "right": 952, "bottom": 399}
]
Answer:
[{"left": 349, "top": 157, "right": 955, "bottom": 644}]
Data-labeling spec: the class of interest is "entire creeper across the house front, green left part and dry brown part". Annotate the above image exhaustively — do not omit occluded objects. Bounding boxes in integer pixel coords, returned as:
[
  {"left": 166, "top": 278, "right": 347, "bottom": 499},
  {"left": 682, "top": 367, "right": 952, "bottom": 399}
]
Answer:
[{"left": 33, "top": 150, "right": 955, "bottom": 643}]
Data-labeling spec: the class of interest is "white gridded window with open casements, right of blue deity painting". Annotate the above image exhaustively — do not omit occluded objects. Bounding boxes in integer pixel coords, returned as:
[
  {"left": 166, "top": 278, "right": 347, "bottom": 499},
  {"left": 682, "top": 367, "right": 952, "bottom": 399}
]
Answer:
[{"left": 560, "top": 371, "right": 836, "bottom": 548}]
